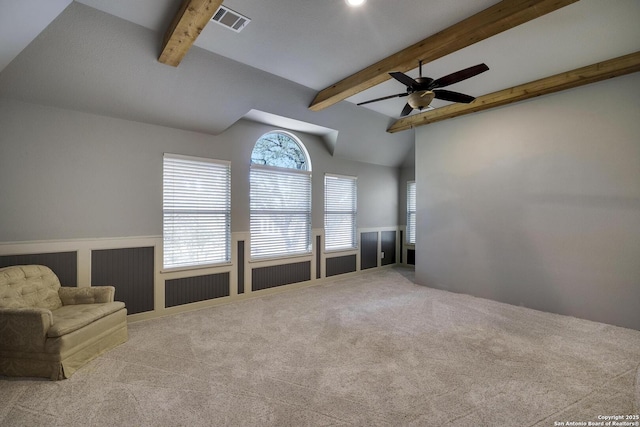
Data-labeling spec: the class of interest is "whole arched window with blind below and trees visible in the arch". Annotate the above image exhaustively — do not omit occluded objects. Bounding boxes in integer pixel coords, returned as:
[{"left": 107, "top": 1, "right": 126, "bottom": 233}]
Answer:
[{"left": 250, "top": 131, "right": 311, "bottom": 259}]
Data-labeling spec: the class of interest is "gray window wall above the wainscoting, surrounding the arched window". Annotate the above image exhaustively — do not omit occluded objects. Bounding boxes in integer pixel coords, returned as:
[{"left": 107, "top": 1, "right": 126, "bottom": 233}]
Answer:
[{"left": 0, "top": 98, "right": 399, "bottom": 242}]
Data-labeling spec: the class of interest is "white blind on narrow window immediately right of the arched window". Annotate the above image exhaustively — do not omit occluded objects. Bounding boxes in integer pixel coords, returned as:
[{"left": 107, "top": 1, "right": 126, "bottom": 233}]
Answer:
[{"left": 324, "top": 174, "right": 358, "bottom": 250}]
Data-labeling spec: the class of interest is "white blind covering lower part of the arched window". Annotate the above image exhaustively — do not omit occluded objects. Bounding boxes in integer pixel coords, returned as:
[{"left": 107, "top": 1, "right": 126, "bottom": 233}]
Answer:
[{"left": 250, "top": 165, "right": 311, "bottom": 259}]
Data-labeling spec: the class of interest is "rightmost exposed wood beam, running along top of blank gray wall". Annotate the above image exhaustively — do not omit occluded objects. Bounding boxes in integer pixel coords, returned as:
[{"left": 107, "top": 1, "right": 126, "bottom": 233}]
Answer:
[{"left": 387, "top": 51, "right": 640, "bottom": 133}]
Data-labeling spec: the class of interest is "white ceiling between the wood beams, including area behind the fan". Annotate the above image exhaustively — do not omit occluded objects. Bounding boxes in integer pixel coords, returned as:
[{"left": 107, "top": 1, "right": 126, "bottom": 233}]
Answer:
[{"left": 70, "top": 0, "right": 640, "bottom": 117}]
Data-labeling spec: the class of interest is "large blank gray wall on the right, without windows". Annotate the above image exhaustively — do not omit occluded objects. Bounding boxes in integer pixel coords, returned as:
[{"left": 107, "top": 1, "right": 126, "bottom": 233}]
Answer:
[{"left": 416, "top": 73, "right": 640, "bottom": 329}]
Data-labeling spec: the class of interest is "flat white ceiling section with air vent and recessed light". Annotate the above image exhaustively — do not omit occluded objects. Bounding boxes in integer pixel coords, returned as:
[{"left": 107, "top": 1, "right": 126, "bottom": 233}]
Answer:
[{"left": 79, "top": 0, "right": 497, "bottom": 90}]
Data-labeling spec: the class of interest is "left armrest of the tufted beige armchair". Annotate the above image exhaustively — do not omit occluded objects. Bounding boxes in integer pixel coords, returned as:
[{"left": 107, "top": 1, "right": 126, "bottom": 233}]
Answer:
[{"left": 0, "top": 308, "right": 53, "bottom": 352}]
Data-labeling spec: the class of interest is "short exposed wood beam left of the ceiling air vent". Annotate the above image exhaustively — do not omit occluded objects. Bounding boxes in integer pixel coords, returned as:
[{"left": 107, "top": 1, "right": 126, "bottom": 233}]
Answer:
[{"left": 158, "top": 0, "right": 222, "bottom": 67}]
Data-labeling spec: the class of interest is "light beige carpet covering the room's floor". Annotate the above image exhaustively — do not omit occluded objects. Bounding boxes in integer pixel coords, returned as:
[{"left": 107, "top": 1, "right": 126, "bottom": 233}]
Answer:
[{"left": 0, "top": 269, "right": 640, "bottom": 427}]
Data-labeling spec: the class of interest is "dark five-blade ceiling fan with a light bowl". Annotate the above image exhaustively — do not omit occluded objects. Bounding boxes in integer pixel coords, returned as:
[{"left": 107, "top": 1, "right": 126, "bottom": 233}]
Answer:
[{"left": 357, "top": 61, "right": 489, "bottom": 117}]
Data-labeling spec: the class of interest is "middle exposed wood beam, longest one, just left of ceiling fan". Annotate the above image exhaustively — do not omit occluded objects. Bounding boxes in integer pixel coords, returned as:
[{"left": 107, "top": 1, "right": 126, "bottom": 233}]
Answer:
[{"left": 309, "top": 0, "right": 578, "bottom": 111}]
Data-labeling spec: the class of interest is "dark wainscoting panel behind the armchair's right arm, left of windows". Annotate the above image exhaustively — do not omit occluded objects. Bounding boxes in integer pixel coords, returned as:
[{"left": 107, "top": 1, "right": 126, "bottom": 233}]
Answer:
[{"left": 91, "top": 247, "right": 154, "bottom": 314}]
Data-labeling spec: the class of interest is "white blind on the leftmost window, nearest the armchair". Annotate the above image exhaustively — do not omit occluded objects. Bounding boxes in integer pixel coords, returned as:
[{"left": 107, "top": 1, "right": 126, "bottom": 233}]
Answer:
[{"left": 163, "top": 154, "right": 231, "bottom": 268}]
